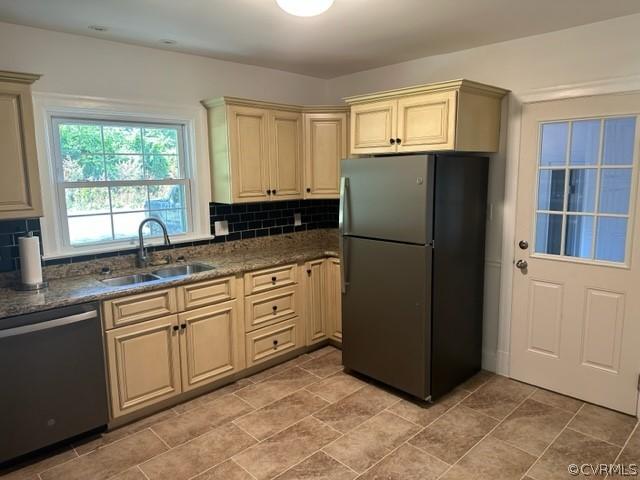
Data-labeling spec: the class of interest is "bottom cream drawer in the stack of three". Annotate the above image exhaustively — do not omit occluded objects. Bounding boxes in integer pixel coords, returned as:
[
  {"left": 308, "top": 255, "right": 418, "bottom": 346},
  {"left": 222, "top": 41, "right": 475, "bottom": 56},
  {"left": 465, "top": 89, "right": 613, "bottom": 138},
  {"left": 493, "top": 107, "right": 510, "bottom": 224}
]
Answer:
[{"left": 246, "top": 318, "right": 300, "bottom": 367}]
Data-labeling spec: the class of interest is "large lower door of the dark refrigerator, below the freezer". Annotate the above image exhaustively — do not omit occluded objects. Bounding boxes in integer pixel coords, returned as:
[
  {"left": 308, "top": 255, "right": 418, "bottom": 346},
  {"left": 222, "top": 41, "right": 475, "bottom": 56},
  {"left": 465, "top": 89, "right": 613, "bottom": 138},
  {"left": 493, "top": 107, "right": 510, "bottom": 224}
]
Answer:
[{"left": 342, "top": 237, "right": 432, "bottom": 399}]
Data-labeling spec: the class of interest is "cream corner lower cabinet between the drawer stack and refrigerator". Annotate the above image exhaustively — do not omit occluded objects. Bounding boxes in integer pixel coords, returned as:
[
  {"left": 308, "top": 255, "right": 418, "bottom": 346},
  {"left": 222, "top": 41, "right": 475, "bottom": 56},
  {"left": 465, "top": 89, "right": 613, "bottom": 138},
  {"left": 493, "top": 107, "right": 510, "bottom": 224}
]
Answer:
[{"left": 304, "top": 258, "right": 342, "bottom": 345}]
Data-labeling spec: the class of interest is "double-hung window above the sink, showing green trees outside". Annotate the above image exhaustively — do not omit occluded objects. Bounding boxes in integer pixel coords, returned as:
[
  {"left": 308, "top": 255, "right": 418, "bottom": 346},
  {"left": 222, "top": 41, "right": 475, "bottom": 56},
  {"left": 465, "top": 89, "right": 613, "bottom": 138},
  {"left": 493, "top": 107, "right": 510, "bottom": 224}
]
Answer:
[{"left": 52, "top": 117, "right": 193, "bottom": 247}]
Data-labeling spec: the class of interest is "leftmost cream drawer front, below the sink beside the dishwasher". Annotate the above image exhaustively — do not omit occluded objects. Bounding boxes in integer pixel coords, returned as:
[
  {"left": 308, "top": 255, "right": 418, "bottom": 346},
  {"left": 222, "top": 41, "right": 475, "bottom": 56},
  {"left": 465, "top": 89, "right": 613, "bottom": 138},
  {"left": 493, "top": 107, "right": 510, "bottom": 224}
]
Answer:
[{"left": 102, "top": 288, "right": 178, "bottom": 330}]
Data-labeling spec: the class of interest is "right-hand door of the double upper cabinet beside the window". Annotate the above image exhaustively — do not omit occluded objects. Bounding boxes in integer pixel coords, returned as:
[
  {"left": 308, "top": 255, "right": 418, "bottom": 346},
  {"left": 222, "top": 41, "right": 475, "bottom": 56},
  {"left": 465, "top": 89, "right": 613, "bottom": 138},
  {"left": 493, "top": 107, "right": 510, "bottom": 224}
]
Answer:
[{"left": 269, "top": 110, "right": 303, "bottom": 200}]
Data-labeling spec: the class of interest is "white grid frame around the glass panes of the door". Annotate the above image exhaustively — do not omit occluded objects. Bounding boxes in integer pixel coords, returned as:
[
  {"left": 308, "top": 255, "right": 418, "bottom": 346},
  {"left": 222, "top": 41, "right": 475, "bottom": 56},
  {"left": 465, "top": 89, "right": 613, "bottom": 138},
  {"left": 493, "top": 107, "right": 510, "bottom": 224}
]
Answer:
[{"left": 530, "top": 113, "right": 640, "bottom": 269}]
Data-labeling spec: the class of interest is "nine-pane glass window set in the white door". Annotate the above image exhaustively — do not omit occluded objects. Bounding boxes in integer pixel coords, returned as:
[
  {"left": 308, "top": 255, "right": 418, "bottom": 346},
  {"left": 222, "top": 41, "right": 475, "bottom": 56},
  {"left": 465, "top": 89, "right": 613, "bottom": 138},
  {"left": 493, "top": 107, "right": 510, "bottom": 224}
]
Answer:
[{"left": 535, "top": 117, "right": 636, "bottom": 263}]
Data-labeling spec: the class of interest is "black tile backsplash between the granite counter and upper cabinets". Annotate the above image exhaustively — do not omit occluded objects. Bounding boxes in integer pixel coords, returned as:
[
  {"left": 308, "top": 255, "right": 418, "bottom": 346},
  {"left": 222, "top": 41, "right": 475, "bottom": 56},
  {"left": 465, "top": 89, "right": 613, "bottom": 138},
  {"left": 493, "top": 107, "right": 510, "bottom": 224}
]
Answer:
[{"left": 0, "top": 200, "right": 338, "bottom": 272}]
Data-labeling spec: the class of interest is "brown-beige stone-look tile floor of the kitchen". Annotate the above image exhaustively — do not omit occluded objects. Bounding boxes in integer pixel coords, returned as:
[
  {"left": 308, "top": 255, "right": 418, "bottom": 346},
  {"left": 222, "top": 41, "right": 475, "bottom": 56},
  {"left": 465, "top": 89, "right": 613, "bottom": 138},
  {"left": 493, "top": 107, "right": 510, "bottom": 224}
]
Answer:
[{"left": 0, "top": 347, "right": 640, "bottom": 480}]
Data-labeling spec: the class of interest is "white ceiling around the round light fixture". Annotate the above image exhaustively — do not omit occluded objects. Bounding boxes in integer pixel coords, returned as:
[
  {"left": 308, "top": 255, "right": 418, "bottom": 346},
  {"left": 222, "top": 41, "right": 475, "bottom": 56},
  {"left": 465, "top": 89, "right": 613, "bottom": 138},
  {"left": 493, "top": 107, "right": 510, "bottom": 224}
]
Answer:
[{"left": 0, "top": 0, "right": 640, "bottom": 78}]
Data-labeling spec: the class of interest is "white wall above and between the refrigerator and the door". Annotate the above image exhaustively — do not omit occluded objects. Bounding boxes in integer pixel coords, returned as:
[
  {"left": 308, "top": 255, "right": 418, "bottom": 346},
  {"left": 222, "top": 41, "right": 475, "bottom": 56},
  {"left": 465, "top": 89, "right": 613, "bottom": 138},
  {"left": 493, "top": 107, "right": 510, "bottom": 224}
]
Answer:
[{"left": 327, "top": 11, "right": 640, "bottom": 373}]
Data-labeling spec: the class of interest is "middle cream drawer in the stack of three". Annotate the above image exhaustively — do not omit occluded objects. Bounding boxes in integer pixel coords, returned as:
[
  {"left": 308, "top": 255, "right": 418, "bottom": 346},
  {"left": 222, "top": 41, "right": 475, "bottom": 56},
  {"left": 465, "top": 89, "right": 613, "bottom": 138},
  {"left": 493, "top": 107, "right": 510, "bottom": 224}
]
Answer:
[{"left": 244, "top": 285, "right": 300, "bottom": 332}]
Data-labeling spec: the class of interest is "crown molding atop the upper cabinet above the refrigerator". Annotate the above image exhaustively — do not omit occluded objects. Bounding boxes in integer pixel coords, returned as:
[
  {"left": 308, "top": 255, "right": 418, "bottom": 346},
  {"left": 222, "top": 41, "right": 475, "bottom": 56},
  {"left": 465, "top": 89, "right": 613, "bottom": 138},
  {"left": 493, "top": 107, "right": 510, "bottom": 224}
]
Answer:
[{"left": 343, "top": 78, "right": 509, "bottom": 105}]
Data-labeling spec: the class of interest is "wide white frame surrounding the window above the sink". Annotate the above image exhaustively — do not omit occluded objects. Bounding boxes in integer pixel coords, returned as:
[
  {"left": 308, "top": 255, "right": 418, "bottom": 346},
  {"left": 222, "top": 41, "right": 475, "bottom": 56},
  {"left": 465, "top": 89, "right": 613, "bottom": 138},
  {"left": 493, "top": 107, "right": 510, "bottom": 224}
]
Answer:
[{"left": 33, "top": 92, "right": 214, "bottom": 260}]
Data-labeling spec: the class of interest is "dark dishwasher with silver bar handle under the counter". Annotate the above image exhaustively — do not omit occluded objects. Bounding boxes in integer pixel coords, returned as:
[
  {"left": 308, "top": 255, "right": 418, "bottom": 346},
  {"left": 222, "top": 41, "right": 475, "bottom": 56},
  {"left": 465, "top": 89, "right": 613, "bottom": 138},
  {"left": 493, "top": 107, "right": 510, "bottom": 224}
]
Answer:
[{"left": 0, "top": 304, "right": 108, "bottom": 463}]
